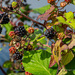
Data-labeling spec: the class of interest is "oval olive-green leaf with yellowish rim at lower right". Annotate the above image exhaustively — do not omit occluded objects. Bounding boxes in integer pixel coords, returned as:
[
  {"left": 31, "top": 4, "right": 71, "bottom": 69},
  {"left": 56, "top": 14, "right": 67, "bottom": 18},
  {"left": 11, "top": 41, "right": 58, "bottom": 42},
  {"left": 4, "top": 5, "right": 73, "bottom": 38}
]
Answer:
[{"left": 61, "top": 51, "right": 74, "bottom": 65}]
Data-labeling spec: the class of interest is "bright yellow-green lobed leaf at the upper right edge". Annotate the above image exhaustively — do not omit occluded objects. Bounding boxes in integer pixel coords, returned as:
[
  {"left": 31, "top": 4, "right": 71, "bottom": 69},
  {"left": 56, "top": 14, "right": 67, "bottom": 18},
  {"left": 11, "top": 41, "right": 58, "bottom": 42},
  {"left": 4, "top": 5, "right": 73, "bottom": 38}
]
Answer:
[{"left": 57, "top": 12, "right": 75, "bottom": 30}]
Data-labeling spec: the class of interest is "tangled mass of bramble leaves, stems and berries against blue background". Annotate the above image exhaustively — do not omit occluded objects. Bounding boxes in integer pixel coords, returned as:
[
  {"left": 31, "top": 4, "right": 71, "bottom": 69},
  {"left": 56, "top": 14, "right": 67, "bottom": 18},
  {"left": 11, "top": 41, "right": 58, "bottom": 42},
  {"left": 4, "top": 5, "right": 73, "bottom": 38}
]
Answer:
[{"left": 0, "top": 0, "right": 75, "bottom": 75}]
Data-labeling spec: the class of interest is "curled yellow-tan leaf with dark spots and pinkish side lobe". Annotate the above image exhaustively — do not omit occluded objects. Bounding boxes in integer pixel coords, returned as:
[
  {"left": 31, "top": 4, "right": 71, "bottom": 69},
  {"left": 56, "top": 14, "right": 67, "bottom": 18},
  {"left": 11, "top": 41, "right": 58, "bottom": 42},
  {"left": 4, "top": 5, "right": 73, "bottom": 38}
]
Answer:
[{"left": 52, "top": 40, "right": 68, "bottom": 65}]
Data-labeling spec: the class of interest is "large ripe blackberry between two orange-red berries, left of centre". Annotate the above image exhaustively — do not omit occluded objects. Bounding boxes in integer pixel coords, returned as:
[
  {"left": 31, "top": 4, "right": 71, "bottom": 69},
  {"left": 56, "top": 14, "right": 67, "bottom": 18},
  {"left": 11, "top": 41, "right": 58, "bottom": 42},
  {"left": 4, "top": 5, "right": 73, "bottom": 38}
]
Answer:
[{"left": 14, "top": 26, "right": 27, "bottom": 37}]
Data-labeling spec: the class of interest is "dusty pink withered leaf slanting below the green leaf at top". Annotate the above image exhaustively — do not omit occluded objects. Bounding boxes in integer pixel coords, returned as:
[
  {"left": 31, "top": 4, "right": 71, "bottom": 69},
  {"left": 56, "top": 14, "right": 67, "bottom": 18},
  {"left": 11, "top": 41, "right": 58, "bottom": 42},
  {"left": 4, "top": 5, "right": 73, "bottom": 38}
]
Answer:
[{"left": 37, "top": 5, "right": 55, "bottom": 21}]
